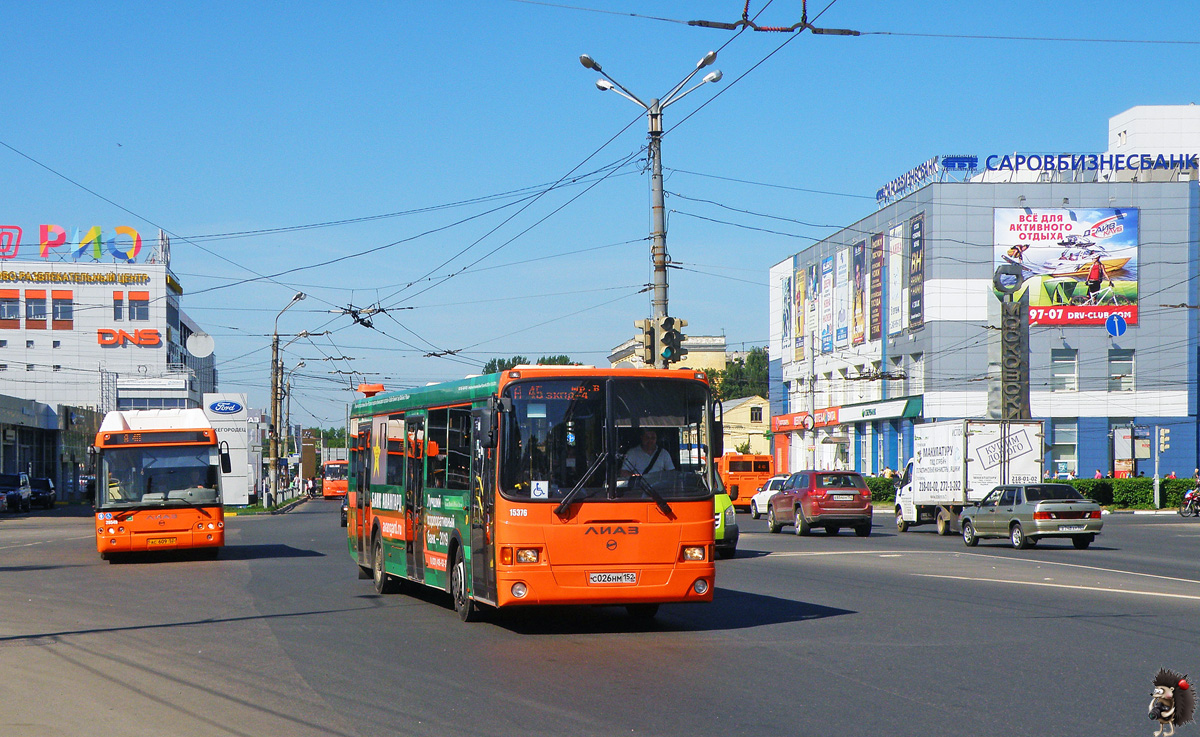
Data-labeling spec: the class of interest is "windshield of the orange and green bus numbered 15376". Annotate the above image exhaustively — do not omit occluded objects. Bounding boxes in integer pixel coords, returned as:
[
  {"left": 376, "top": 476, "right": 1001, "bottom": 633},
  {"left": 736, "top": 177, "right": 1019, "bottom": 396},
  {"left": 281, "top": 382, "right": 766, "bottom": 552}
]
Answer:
[{"left": 500, "top": 378, "right": 712, "bottom": 502}]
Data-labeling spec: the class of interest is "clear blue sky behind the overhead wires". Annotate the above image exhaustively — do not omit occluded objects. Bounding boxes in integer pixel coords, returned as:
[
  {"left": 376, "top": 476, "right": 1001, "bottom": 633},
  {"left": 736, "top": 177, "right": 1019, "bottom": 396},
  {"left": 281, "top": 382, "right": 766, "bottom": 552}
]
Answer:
[{"left": 0, "top": 0, "right": 1200, "bottom": 425}]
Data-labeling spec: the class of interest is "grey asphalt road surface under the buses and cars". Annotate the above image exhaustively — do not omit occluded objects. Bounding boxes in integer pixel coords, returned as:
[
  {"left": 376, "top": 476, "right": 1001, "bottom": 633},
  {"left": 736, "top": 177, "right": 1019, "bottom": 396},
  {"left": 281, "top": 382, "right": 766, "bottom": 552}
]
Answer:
[{"left": 0, "top": 502, "right": 1200, "bottom": 737}]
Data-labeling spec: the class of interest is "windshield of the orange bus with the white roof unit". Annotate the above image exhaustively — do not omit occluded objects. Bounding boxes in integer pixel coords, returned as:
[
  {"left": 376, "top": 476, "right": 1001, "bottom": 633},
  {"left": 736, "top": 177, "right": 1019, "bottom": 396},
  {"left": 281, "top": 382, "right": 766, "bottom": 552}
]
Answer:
[{"left": 97, "top": 445, "right": 221, "bottom": 509}]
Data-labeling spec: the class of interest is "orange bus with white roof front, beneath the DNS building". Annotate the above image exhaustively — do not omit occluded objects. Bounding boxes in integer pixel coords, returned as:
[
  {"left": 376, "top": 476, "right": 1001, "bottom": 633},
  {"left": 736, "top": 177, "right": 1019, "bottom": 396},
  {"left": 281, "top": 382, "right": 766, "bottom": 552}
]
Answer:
[{"left": 90, "top": 409, "right": 230, "bottom": 561}]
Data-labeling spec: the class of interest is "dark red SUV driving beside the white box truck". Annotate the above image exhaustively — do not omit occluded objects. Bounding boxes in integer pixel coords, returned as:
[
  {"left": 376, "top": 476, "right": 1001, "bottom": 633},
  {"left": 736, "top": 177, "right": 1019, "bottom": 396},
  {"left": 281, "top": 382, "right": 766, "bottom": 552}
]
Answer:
[{"left": 767, "top": 471, "right": 872, "bottom": 538}]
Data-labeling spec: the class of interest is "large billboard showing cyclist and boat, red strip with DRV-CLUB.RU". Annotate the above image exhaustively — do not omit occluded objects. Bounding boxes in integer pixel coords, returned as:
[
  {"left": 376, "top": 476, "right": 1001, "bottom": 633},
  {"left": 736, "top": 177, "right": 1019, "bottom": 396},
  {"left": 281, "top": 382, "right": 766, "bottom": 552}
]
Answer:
[{"left": 992, "top": 208, "right": 1138, "bottom": 325}]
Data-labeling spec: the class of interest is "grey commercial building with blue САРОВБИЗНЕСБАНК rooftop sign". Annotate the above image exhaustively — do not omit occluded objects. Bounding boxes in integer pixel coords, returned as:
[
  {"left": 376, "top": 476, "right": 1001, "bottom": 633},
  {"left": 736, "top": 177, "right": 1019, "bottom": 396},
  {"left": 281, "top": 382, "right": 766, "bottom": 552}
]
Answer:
[{"left": 770, "top": 106, "right": 1200, "bottom": 478}]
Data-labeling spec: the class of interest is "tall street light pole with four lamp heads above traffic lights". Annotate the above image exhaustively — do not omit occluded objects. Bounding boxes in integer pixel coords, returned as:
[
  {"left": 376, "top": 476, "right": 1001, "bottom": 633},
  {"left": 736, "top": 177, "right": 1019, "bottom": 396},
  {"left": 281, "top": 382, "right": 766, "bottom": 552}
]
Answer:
[{"left": 580, "top": 52, "right": 721, "bottom": 369}]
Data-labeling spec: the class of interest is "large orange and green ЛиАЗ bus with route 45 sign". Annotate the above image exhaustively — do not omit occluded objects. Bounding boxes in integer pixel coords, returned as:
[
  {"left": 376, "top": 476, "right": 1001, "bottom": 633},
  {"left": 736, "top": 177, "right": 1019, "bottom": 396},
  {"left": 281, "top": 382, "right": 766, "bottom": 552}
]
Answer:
[{"left": 347, "top": 366, "right": 721, "bottom": 622}]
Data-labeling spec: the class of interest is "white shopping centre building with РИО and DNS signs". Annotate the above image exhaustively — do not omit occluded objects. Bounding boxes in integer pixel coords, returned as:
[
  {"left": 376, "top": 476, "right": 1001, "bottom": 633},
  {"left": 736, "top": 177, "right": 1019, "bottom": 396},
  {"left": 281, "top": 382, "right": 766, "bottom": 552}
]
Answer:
[{"left": 0, "top": 226, "right": 217, "bottom": 497}]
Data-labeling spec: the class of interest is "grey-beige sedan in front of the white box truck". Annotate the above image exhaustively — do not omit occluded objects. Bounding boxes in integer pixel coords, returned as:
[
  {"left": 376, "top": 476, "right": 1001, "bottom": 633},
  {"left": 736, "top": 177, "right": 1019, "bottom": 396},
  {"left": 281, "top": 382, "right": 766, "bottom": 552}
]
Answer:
[{"left": 959, "top": 484, "right": 1104, "bottom": 550}]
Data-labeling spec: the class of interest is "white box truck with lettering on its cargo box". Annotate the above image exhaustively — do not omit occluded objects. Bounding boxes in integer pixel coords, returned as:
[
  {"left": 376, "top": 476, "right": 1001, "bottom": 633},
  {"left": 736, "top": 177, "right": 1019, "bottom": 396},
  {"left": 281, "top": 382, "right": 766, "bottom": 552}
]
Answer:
[{"left": 896, "top": 420, "right": 1043, "bottom": 535}]
